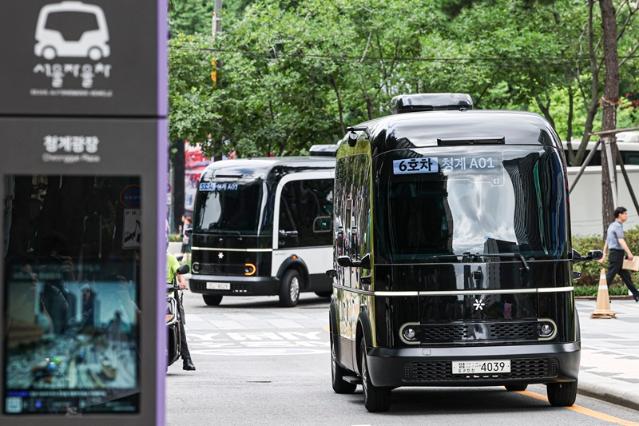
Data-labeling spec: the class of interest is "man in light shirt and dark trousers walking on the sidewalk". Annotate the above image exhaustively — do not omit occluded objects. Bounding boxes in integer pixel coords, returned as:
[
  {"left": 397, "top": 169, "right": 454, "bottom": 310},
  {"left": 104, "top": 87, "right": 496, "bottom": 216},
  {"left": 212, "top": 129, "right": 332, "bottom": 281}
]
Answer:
[{"left": 599, "top": 207, "right": 639, "bottom": 302}]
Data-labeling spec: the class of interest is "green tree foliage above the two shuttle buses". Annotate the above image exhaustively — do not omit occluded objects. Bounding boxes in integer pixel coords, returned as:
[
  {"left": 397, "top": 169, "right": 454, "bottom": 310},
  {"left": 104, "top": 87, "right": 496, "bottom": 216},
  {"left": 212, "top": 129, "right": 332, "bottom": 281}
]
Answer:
[{"left": 170, "top": 0, "right": 639, "bottom": 156}]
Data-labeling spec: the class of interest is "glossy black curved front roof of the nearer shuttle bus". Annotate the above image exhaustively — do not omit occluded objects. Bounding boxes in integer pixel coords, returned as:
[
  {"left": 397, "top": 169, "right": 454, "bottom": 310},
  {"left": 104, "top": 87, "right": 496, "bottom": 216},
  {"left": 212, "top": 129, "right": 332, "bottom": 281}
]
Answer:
[{"left": 342, "top": 110, "right": 561, "bottom": 151}]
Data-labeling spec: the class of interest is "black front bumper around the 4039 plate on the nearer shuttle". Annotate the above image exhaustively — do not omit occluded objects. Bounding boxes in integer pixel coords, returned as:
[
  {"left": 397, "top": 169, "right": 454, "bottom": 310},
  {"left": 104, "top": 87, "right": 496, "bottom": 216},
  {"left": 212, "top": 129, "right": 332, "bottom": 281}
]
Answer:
[{"left": 366, "top": 342, "right": 581, "bottom": 387}]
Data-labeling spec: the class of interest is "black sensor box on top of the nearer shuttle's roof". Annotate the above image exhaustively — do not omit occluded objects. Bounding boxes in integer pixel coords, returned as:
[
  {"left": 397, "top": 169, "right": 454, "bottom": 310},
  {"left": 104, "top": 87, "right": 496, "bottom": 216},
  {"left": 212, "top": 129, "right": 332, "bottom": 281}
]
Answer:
[{"left": 391, "top": 93, "right": 473, "bottom": 114}]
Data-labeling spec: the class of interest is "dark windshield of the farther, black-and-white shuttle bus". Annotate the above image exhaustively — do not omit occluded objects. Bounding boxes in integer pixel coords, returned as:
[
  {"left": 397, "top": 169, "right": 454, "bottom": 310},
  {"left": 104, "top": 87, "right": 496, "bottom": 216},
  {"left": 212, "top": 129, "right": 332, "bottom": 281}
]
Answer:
[{"left": 194, "top": 180, "right": 264, "bottom": 235}]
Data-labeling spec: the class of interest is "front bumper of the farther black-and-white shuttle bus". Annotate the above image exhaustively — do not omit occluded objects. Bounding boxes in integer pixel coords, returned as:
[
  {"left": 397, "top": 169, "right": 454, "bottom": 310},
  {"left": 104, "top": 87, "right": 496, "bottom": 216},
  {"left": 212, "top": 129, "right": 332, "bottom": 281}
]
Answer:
[{"left": 189, "top": 274, "right": 280, "bottom": 296}]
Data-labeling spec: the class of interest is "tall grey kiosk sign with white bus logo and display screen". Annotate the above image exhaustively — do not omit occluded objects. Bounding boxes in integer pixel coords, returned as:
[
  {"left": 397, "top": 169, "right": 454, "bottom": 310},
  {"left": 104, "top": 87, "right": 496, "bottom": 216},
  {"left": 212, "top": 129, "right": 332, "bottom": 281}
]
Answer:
[{"left": 0, "top": 0, "right": 168, "bottom": 426}]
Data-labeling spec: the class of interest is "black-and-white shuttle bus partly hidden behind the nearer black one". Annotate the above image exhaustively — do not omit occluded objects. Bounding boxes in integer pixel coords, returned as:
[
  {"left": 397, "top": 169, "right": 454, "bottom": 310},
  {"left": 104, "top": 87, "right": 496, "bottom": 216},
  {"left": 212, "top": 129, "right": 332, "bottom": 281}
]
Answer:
[{"left": 190, "top": 145, "right": 335, "bottom": 306}]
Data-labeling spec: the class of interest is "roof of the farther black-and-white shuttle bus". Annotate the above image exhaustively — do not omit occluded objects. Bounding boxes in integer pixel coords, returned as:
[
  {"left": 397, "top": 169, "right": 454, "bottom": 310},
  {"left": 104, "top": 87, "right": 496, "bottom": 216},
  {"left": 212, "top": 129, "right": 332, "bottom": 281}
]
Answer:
[{"left": 202, "top": 156, "right": 335, "bottom": 179}]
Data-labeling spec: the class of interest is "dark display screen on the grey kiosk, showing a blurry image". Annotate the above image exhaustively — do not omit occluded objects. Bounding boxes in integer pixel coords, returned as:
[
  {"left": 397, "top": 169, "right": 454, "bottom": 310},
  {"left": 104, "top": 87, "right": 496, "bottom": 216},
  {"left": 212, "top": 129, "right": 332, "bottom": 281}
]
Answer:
[{"left": 2, "top": 175, "right": 142, "bottom": 415}]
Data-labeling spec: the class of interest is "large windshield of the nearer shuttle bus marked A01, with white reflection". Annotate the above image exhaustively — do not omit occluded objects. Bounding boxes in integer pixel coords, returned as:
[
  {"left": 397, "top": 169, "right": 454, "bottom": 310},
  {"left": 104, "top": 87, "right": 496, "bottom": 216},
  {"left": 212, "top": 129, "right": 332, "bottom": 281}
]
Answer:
[{"left": 375, "top": 145, "right": 568, "bottom": 263}]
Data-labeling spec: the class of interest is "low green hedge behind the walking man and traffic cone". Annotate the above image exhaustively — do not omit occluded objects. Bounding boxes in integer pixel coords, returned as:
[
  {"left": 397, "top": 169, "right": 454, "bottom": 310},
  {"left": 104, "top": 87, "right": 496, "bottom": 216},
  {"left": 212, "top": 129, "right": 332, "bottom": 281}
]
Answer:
[{"left": 572, "top": 227, "right": 639, "bottom": 288}]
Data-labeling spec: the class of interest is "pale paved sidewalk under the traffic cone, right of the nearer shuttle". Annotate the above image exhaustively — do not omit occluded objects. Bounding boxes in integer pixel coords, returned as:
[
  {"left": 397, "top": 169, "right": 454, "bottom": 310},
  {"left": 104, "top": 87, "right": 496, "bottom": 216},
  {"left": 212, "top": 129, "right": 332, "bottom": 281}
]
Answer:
[{"left": 577, "top": 300, "right": 639, "bottom": 410}]
